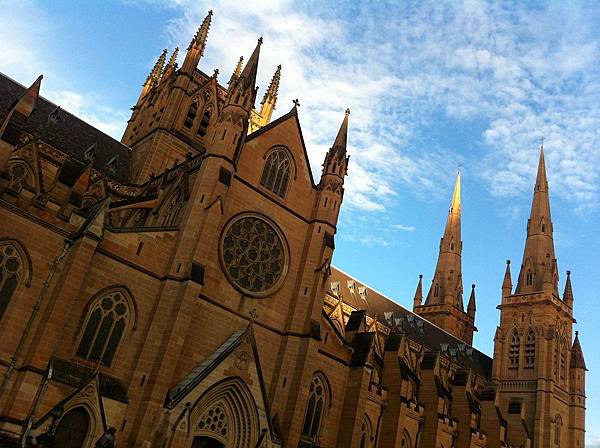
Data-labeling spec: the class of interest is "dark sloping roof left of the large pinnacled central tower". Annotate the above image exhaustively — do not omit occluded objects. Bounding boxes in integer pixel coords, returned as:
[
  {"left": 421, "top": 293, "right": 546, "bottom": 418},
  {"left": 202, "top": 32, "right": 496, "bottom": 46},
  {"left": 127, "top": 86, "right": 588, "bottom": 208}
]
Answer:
[{"left": 0, "top": 72, "right": 131, "bottom": 182}]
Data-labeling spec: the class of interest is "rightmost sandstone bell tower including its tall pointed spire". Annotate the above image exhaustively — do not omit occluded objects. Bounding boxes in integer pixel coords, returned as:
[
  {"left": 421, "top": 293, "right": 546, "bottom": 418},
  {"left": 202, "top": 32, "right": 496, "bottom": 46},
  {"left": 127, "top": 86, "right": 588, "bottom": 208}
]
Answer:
[{"left": 493, "top": 146, "right": 585, "bottom": 448}]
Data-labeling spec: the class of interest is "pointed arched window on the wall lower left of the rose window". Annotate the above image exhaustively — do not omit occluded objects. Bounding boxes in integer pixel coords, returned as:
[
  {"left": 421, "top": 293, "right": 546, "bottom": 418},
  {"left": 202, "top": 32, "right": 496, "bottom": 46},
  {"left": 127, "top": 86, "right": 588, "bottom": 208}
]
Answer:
[{"left": 77, "top": 290, "right": 132, "bottom": 366}]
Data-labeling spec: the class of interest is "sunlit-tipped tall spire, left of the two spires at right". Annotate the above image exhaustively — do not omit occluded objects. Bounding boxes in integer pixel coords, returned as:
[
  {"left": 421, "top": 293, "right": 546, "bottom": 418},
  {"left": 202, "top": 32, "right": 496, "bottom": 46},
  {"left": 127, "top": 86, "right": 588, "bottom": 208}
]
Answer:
[{"left": 425, "top": 172, "right": 464, "bottom": 311}]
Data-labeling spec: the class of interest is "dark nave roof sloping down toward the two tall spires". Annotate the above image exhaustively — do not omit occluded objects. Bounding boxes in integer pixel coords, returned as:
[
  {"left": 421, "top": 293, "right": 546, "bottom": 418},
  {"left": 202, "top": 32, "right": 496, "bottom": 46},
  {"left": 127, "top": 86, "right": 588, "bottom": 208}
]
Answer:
[{"left": 329, "top": 266, "right": 492, "bottom": 377}]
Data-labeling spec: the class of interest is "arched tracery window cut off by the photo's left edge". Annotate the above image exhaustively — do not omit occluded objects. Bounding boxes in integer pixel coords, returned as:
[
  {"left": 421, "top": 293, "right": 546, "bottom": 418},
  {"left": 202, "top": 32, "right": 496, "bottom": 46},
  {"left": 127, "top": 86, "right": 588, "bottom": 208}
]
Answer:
[{"left": 0, "top": 240, "right": 29, "bottom": 319}]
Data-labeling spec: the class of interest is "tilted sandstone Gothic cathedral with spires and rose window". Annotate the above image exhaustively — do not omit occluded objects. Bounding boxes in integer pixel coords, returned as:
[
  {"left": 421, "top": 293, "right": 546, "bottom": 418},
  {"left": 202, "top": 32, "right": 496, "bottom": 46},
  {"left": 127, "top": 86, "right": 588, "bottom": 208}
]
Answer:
[{"left": 0, "top": 12, "right": 586, "bottom": 448}]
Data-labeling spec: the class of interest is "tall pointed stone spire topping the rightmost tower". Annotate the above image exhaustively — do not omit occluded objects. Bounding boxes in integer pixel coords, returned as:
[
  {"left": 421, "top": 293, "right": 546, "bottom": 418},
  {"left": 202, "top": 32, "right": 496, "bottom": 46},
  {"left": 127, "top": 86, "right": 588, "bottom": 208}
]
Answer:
[{"left": 515, "top": 145, "right": 558, "bottom": 295}]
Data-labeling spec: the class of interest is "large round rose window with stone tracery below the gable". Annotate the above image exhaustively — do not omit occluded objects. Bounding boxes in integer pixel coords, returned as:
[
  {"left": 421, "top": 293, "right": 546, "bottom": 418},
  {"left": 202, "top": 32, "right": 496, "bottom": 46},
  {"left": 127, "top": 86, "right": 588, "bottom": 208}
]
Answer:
[{"left": 221, "top": 215, "right": 287, "bottom": 297}]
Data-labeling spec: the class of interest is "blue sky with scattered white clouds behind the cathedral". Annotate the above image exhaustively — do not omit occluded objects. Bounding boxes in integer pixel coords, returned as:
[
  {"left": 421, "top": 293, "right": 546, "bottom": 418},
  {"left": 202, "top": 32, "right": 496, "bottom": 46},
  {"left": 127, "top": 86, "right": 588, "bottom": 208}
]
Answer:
[{"left": 0, "top": 0, "right": 600, "bottom": 446}]
